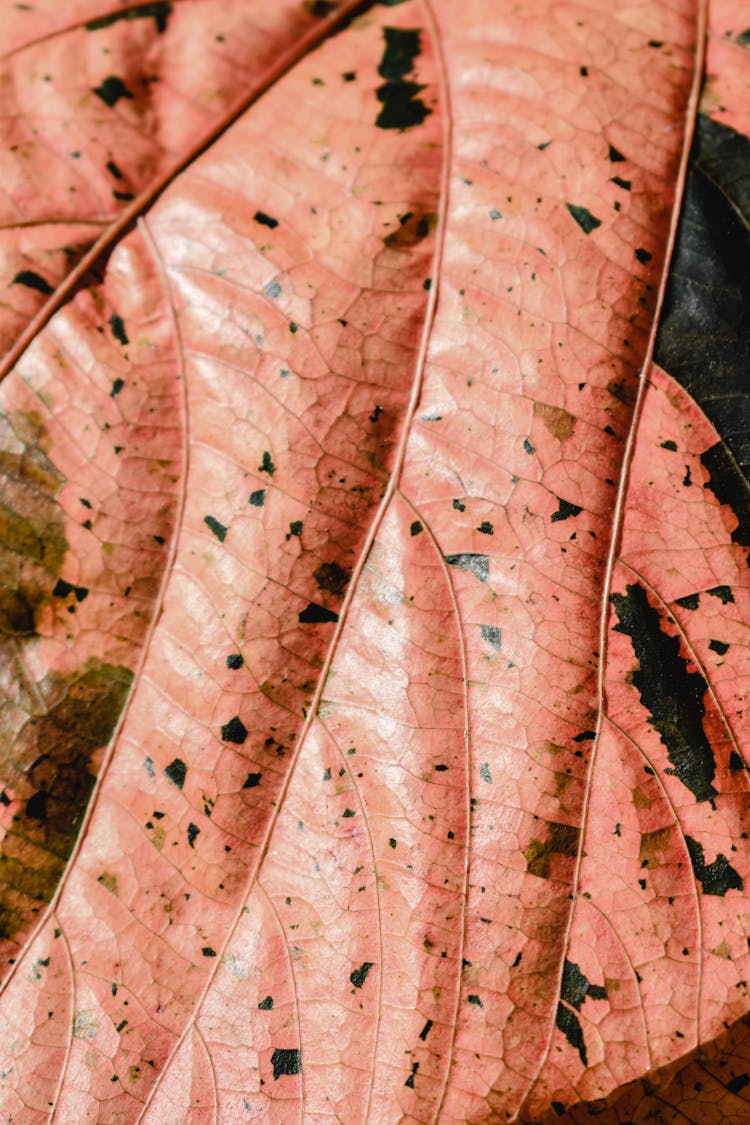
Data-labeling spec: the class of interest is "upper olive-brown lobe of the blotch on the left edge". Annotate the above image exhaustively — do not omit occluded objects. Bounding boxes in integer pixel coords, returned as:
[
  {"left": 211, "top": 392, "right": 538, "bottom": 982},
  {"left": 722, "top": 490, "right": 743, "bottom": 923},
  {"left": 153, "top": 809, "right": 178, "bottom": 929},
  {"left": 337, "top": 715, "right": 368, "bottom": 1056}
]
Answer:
[{"left": 0, "top": 411, "right": 67, "bottom": 650}]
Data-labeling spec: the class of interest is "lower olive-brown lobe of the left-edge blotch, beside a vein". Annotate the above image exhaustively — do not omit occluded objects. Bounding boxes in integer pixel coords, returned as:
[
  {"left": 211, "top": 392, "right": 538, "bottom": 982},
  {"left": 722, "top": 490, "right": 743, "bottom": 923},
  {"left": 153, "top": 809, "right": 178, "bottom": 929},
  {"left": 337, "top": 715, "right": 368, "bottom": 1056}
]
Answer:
[{"left": 0, "top": 659, "right": 133, "bottom": 938}]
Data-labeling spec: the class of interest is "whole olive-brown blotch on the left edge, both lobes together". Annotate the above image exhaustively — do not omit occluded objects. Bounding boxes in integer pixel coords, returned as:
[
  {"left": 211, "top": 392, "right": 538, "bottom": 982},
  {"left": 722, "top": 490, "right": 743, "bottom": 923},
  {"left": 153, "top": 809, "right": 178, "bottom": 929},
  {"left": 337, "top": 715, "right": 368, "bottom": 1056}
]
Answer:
[{"left": 0, "top": 411, "right": 133, "bottom": 939}]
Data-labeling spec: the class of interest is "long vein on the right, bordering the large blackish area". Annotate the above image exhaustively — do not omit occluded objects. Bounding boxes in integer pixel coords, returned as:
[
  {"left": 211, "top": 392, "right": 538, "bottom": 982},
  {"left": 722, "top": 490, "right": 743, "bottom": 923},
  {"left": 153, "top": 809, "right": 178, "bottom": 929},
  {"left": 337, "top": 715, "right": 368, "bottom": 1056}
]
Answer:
[{"left": 508, "top": 0, "right": 708, "bottom": 1125}]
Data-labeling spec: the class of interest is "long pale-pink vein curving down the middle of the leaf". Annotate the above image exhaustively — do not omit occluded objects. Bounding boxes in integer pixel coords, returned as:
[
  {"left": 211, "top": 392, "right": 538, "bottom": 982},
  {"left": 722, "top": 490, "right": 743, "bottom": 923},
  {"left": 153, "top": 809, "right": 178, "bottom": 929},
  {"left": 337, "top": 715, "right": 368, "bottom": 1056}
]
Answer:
[{"left": 136, "top": 0, "right": 451, "bottom": 1125}]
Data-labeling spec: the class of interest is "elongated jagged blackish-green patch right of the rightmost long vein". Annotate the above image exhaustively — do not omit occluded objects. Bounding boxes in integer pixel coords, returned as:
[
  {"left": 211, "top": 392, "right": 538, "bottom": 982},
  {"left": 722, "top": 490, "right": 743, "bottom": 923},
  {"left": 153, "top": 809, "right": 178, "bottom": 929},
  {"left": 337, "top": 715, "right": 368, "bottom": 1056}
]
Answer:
[{"left": 612, "top": 584, "right": 716, "bottom": 801}]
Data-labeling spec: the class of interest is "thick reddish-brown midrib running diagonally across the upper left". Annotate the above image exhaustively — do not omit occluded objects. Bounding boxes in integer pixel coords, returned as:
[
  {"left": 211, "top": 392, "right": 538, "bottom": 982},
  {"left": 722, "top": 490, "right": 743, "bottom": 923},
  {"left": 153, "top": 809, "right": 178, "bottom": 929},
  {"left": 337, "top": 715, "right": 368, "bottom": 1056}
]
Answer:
[{"left": 0, "top": 0, "right": 362, "bottom": 380}]
